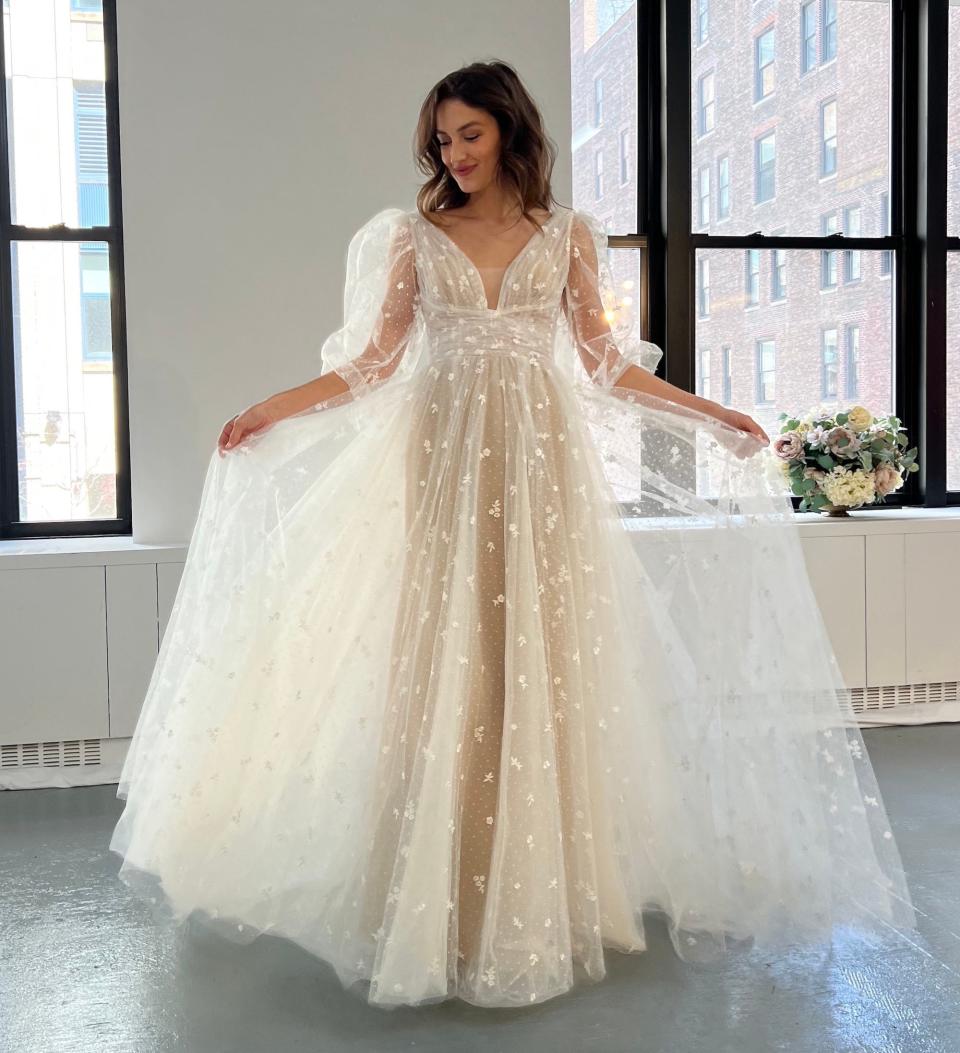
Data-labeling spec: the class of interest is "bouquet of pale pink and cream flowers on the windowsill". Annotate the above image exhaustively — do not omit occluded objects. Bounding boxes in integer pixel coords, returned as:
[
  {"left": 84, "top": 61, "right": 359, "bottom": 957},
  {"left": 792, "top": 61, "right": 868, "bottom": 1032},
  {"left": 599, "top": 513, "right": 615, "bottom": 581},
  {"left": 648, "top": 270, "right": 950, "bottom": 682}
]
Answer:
[{"left": 773, "top": 405, "right": 919, "bottom": 516}]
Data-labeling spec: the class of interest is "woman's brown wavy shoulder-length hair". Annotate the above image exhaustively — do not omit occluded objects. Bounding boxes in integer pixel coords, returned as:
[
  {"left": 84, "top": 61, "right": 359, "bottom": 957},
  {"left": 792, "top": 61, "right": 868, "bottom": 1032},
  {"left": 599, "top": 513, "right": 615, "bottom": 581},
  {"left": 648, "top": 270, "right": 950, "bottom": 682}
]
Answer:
[{"left": 414, "top": 60, "right": 558, "bottom": 237}]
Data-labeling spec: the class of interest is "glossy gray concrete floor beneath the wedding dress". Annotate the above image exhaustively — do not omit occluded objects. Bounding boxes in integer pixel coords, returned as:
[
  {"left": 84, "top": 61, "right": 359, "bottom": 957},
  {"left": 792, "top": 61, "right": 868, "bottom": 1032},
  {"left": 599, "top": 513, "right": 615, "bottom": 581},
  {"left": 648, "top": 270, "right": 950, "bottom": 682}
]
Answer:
[{"left": 0, "top": 724, "right": 960, "bottom": 1053}]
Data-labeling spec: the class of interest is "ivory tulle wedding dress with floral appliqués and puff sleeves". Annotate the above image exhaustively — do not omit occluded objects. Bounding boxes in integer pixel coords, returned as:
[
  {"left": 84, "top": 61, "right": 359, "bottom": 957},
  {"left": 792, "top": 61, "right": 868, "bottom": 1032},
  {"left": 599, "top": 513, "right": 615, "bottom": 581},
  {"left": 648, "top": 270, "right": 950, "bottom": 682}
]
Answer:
[{"left": 109, "top": 206, "right": 915, "bottom": 1007}]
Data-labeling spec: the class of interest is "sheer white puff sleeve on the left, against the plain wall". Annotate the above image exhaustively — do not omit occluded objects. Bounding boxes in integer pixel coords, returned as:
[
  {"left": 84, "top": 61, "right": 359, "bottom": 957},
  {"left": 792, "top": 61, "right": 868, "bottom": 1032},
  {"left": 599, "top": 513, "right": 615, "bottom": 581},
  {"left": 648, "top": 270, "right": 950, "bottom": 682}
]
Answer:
[{"left": 320, "top": 208, "right": 419, "bottom": 399}]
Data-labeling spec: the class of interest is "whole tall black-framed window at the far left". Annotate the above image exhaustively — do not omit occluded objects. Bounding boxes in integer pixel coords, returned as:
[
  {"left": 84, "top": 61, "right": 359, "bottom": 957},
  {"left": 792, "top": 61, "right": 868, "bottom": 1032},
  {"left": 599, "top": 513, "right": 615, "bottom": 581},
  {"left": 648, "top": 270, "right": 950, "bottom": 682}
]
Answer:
[{"left": 0, "top": 0, "right": 132, "bottom": 539}]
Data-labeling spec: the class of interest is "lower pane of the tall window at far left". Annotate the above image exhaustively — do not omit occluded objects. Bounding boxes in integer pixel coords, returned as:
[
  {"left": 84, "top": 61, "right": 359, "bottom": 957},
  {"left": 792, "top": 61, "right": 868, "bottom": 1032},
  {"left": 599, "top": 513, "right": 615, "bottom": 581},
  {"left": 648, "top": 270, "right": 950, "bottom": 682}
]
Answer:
[{"left": 11, "top": 241, "right": 117, "bottom": 521}]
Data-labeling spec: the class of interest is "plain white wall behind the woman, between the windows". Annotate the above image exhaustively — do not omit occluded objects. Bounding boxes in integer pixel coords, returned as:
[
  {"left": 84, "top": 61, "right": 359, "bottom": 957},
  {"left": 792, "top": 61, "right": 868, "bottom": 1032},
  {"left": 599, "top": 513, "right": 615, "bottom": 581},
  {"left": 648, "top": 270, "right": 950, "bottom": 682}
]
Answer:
[{"left": 118, "top": 0, "right": 571, "bottom": 543}]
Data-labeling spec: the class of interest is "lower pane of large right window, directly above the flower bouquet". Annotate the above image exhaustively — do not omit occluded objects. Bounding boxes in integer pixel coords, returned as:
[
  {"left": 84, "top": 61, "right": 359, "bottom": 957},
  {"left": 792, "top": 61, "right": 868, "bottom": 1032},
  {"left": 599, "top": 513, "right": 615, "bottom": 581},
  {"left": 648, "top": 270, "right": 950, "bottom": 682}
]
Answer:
[{"left": 696, "top": 249, "right": 892, "bottom": 437}]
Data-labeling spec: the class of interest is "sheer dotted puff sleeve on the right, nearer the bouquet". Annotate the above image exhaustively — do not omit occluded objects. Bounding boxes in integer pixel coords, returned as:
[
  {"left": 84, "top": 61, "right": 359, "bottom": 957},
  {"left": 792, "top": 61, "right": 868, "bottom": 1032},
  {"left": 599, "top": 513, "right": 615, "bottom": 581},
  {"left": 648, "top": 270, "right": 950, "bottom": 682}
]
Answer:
[{"left": 563, "top": 211, "right": 663, "bottom": 388}]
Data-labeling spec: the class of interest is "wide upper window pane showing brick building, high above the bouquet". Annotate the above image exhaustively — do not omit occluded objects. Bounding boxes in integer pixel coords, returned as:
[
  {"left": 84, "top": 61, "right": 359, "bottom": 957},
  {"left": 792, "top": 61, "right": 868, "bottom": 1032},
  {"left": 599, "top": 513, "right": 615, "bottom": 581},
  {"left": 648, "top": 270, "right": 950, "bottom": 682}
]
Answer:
[{"left": 691, "top": 0, "right": 892, "bottom": 237}]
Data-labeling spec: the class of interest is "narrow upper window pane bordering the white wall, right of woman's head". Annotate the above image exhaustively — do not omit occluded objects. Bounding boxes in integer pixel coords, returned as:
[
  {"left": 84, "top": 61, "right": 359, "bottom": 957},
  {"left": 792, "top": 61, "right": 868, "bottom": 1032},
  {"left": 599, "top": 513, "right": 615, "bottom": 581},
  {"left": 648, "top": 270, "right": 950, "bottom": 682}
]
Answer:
[{"left": 571, "top": 0, "right": 644, "bottom": 234}]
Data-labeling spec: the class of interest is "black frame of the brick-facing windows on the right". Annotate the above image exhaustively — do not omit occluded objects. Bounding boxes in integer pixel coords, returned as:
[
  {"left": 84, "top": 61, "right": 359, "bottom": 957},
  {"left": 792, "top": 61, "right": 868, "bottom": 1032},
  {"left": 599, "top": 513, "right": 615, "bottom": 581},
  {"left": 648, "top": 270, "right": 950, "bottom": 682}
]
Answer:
[{"left": 611, "top": 0, "right": 960, "bottom": 508}]
